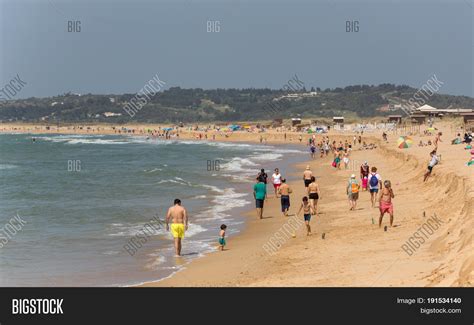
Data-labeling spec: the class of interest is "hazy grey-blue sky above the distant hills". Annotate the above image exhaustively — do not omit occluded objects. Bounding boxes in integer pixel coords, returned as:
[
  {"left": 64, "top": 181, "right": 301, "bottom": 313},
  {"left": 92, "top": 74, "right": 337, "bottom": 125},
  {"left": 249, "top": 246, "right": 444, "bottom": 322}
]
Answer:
[{"left": 0, "top": 0, "right": 474, "bottom": 98}]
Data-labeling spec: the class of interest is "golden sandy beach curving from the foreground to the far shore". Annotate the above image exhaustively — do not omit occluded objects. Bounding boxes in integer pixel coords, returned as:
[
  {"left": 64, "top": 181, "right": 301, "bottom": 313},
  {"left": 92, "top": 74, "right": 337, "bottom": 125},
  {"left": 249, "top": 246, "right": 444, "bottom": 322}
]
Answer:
[{"left": 0, "top": 123, "right": 474, "bottom": 287}]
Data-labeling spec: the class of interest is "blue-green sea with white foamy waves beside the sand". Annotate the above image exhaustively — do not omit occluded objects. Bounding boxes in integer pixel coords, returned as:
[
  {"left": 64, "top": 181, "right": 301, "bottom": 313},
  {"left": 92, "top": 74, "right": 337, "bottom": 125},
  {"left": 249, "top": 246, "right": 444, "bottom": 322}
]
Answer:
[{"left": 0, "top": 134, "right": 307, "bottom": 286}]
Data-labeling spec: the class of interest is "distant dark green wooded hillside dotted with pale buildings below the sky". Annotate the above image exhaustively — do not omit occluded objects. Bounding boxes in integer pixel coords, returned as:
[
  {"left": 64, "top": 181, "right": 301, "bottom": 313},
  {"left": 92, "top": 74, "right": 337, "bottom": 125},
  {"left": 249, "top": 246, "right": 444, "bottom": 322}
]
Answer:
[{"left": 0, "top": 84, "right": 474, "bottom": 123}]
